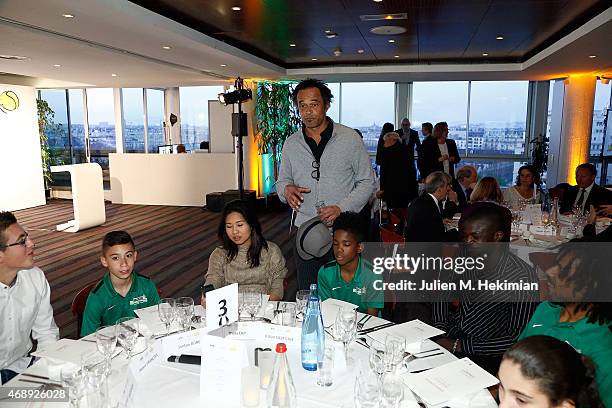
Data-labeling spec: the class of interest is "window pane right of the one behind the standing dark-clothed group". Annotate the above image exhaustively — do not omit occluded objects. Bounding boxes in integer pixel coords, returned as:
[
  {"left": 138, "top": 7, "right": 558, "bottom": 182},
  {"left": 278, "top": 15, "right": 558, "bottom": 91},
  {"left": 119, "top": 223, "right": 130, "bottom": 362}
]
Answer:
[{"left": 468, "top": 81, "right": 529, "bottom": 155}]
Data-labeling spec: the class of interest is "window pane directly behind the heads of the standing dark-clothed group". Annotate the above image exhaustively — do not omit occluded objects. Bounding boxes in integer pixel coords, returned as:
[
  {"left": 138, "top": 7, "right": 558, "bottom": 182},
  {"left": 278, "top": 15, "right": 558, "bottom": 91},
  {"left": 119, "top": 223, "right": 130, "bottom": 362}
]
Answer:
[{"left": 410, "top": 81, "right": 468, "bottom": 152}]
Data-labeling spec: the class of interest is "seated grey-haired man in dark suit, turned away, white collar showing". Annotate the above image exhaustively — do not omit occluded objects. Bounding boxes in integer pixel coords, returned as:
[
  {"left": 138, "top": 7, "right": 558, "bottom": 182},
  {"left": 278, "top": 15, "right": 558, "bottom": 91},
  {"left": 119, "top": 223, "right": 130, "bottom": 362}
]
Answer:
[{"left": 404, "top": 171, "right": 451, "bottom": 242}]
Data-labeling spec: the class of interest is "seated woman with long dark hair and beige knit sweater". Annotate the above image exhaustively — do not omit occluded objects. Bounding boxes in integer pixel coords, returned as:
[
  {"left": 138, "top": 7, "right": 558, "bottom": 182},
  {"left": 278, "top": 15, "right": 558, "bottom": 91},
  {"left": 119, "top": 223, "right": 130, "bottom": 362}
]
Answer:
[{"left": 204, "top": 200, "right": 287, "bottom": 300}]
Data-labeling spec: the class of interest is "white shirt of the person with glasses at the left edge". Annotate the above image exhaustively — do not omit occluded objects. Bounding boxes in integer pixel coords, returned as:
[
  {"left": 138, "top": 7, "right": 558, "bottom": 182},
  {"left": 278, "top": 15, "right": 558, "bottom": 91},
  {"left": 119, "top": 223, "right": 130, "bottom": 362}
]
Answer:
[{"left": 0, "top": 267, "right": 59, "bottom": 372}]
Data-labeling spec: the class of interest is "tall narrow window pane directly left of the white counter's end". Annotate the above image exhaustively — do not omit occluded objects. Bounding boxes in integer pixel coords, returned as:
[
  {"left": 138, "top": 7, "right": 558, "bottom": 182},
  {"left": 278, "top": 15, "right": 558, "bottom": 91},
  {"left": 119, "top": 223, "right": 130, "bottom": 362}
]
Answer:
[{"left": 87, "top": 88, "right": 116, "bottom": 169}]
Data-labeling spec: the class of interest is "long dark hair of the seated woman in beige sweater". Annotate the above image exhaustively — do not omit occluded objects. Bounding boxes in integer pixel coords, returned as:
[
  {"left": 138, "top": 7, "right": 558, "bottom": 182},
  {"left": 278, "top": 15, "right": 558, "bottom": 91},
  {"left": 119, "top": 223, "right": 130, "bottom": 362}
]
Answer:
[{"left": 217, "top": 200, "right": 268, "bottom": 268}]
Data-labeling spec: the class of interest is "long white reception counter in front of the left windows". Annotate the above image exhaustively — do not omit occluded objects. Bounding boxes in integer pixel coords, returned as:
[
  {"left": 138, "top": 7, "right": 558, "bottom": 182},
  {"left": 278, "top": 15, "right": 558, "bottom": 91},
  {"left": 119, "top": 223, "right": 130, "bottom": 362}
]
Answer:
[{"left": 109, "top": 153, "right": 238, "bottom": 206}]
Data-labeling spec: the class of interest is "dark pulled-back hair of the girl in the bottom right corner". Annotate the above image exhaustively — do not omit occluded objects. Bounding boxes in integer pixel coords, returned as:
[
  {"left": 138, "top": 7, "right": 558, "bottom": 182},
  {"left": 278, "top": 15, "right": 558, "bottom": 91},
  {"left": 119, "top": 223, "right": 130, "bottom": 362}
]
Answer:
[{"left": 504, "top": 335, "right": 605, "bottom": 408}]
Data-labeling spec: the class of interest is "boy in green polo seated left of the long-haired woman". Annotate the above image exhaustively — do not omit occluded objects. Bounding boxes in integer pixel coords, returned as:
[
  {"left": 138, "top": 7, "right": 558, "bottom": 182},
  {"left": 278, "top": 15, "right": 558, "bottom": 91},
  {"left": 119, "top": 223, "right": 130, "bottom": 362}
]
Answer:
[{"left": 81, "top": 231, "right": 159, "bottom": 336}]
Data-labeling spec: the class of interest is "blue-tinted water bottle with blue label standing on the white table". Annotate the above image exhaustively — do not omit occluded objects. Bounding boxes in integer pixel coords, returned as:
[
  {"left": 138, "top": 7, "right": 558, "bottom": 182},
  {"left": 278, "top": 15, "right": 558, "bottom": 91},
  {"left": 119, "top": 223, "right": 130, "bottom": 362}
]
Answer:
[{"left": 302, "top": 283, "right": 325, "bottom": 371}]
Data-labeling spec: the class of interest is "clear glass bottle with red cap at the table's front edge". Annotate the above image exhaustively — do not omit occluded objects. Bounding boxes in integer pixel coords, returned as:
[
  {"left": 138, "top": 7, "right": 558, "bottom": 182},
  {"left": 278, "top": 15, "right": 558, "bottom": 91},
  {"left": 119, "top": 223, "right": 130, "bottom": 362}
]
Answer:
[{"left": 267, "top": 343, "right": 297, "bottom": 408}]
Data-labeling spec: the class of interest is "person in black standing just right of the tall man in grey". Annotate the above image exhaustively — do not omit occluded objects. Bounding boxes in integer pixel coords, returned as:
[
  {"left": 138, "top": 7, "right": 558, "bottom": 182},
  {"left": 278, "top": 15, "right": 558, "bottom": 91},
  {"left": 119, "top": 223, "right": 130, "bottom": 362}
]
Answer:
[{"left": 380, "top": 132, "right": 419, "bottom": 208}]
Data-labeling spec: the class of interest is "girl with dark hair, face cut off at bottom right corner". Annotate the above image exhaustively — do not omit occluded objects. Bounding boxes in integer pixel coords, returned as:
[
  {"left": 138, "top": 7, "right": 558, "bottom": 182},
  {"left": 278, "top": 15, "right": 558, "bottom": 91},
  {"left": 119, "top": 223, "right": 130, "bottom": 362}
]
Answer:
[{"left": 498, "top": 336, "right": 609, "bottom": 408}]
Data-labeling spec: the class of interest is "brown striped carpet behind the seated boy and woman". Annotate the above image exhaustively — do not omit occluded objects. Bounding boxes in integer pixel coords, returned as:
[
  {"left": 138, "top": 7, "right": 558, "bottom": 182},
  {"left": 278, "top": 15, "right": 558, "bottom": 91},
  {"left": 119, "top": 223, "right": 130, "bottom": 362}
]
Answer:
[{"left": 15, "top": 200, "right": 295, "bottom": 338}]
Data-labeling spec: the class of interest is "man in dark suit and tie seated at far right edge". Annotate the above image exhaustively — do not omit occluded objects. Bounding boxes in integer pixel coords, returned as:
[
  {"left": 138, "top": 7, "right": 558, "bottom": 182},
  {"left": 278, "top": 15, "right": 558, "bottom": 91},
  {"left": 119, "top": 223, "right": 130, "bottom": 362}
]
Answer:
[{"left": 560, "top": 163, "right": 612, "bottom": 213}]
